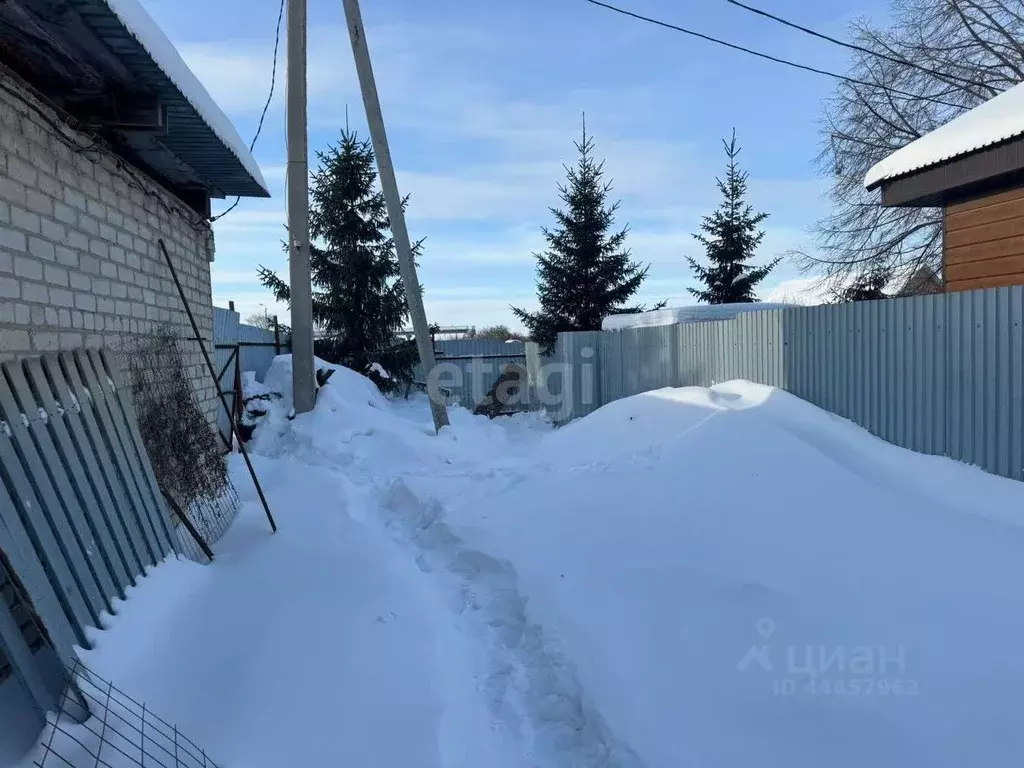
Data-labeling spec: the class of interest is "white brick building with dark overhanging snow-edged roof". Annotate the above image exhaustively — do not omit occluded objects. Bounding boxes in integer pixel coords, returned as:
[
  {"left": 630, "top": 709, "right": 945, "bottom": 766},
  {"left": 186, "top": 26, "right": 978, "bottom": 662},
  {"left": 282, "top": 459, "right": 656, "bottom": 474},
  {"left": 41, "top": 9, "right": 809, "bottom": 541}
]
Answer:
[{"left": 0, "top": 0, "right": 268, "bottom": 419}]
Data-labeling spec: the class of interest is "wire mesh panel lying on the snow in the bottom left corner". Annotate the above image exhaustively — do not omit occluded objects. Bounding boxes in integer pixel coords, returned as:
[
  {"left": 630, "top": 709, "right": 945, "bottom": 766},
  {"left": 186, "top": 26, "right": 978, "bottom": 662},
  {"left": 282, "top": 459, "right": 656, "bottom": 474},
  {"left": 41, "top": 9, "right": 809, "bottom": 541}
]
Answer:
[{"left": 32, "top": 663, "right": 223, "bottom": 768}]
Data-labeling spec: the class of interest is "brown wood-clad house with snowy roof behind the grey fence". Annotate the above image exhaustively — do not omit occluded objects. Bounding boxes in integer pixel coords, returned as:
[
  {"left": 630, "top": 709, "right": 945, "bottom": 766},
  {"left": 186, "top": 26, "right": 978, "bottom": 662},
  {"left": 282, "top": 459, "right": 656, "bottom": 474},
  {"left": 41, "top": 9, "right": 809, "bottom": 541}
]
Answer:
[{"left": 864, "top": 84, "right": 1024, "bottom": 291}]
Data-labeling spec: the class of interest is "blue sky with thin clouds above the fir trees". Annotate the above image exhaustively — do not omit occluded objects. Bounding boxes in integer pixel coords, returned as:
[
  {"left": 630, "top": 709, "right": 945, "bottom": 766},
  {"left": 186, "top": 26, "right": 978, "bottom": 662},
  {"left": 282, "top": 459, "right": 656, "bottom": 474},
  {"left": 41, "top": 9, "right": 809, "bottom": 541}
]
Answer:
[{"left": 143, "top": 0, "right": 886, "bottom": 327}]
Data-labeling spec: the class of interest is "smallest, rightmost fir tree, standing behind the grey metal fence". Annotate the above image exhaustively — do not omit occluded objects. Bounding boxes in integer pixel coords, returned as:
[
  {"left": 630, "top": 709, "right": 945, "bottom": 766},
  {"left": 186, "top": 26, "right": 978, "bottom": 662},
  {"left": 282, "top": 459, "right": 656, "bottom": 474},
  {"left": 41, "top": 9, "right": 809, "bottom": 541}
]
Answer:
[{"left": 686, "top": 129, "right": 780, "bottom": 304}]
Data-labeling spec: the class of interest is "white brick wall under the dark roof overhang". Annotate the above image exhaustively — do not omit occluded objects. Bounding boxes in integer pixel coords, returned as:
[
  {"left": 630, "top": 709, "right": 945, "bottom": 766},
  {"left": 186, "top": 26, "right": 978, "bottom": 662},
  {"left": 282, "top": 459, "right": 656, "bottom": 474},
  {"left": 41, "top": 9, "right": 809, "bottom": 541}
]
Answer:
[{"left": 0, "top": 71, "right": 219, "bottom": 423}]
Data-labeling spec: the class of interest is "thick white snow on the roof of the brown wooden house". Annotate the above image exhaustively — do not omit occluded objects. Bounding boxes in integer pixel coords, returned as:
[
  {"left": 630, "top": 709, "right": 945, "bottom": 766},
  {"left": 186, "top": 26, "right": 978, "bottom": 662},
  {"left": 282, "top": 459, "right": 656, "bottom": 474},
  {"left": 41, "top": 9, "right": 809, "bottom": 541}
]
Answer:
[{"left": 864, "top": 83, "right": 1024, "bottom": 189}]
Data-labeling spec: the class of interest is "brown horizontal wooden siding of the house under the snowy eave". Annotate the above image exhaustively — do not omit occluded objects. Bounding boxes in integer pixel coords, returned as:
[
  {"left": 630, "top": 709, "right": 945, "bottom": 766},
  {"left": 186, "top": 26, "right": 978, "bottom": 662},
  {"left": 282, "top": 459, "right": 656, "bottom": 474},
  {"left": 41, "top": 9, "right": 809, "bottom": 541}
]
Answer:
[{"left": 944, "top": 187, "right": 1024, "bottom": 291}]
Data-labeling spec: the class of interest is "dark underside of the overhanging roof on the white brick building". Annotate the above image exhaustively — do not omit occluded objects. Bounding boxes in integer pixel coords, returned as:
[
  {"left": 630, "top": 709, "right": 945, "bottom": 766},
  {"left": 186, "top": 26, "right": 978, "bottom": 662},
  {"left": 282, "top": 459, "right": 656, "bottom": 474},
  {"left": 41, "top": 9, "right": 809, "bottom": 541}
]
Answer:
[{"left": 0, "top": 0, "right": 269, "bottom": 198}]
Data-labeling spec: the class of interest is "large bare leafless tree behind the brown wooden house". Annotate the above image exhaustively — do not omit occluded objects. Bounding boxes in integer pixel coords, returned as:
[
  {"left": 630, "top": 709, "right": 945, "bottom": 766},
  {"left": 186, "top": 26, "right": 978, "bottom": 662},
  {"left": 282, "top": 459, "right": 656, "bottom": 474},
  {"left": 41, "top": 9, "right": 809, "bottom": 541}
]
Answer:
[{"left": 799, "top": 0, "right": 1024, "bottom": 286}]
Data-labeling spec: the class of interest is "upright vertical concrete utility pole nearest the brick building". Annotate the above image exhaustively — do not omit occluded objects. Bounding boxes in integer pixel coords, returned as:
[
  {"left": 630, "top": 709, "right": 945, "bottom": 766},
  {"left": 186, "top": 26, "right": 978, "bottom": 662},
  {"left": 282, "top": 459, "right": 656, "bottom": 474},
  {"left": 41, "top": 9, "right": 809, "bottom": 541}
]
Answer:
[{"left": 288, "top": 0, "right": 315, "bottom": 414}]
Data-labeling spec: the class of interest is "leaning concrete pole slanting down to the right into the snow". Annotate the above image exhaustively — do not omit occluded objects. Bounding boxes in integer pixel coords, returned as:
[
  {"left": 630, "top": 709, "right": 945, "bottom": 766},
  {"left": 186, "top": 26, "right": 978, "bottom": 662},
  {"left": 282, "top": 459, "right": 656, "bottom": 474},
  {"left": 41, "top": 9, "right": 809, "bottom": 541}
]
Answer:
[{"left": 342, "top": 0, "right": 449, "bottom": 430}]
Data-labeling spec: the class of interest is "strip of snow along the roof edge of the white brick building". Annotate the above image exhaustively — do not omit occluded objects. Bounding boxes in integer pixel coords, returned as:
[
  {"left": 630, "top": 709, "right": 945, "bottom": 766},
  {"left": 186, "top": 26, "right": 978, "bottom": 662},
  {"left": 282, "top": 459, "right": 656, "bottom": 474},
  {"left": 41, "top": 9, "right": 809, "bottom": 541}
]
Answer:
[{"left": 103, "top": 0, "right": 269, "bottom": 195}]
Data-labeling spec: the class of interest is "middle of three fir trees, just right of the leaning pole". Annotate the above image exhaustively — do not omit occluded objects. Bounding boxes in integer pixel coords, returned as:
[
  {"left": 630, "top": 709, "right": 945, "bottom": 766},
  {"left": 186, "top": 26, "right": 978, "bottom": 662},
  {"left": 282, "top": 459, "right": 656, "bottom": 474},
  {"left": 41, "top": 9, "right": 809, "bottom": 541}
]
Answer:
[{"left": 512, "top": 120, "right": 648, "bottom": 349}]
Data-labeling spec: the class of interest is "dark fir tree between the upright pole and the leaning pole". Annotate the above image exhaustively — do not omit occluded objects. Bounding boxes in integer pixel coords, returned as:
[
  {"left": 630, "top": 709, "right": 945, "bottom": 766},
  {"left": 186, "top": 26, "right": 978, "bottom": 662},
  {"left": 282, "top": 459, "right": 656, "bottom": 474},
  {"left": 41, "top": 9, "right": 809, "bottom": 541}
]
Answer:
[{"left": 259, "top": 128, "right": 419, "bottom": 389}]
